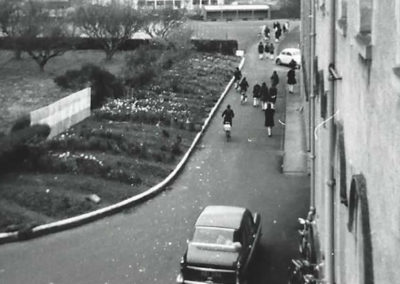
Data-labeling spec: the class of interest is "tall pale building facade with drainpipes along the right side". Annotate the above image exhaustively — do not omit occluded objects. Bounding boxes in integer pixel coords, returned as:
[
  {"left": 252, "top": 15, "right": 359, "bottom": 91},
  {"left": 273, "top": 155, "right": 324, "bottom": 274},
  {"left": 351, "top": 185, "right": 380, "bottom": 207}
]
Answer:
[{"left": 301, "top": 0, "right": 400, "bottom": 284}]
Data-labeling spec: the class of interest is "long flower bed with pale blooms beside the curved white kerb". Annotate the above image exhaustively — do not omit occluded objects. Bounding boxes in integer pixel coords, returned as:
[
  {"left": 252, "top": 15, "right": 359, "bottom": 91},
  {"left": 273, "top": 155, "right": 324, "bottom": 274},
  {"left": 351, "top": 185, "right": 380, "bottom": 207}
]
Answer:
[{"left": 0, "top": 53, "right": 239, "bottom": 231}]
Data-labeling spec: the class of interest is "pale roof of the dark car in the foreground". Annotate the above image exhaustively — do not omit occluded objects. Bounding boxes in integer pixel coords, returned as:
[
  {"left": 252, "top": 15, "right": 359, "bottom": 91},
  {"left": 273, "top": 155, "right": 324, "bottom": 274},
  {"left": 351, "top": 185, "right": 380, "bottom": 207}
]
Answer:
[{"left": 196, "top": 205, "right": 247, "bottom": 229}]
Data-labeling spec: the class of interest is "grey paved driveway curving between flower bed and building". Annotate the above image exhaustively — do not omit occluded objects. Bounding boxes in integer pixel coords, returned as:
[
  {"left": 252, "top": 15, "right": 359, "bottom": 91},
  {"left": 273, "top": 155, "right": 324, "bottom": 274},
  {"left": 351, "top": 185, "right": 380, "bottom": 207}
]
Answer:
[{"left": 0, "top": 25, "right": 309, "bottom": 284}]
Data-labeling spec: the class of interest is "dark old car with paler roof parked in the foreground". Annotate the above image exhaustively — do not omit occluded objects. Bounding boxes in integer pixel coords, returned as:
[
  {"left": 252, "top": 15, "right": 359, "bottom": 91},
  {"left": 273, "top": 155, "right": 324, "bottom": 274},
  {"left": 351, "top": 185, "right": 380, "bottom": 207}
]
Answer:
[{"left": 176, "top": 206, "right": 261, "bottom": 284}]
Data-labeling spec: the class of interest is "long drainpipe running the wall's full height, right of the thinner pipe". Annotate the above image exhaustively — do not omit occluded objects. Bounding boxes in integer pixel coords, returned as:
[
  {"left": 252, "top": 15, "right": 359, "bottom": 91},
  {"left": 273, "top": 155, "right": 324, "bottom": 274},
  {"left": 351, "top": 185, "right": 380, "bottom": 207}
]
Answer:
[{"left": 325, "top": 0, "right": 336, "bottom": 284}]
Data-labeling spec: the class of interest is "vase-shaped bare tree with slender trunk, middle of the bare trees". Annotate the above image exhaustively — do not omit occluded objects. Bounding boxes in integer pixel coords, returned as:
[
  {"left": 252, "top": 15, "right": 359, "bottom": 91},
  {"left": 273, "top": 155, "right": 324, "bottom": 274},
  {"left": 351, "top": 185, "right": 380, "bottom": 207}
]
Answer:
[{"left": 73, "top": 2, "right": 143, "bottom": 60}]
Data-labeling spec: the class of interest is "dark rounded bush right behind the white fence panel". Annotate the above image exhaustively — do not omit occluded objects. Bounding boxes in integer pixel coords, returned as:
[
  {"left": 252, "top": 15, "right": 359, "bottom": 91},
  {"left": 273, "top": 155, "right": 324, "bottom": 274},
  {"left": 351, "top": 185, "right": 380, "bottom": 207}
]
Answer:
[{"left": 54, "top": 64, "right": 124, "bottom": 109}]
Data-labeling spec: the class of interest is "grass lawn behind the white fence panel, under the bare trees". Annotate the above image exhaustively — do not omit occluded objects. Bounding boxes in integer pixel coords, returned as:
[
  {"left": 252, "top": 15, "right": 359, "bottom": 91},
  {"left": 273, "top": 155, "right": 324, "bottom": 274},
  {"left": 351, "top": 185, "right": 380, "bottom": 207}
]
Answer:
[{"left": 0, "top": 50, "right": 125, "bottom": 133}]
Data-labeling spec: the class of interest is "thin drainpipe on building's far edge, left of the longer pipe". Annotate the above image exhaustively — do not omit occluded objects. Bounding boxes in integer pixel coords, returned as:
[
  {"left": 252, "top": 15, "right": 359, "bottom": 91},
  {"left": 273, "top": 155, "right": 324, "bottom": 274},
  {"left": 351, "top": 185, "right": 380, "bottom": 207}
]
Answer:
[{"left": 309, "top": 0, "right": 318, "bottom": 209}]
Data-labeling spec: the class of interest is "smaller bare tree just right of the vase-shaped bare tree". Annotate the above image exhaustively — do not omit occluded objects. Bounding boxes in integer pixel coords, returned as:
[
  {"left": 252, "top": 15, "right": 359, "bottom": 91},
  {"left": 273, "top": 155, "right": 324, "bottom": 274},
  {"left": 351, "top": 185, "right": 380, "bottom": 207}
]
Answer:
[{"left": 144, "top": 8, "right": 185, "bottom": 39}]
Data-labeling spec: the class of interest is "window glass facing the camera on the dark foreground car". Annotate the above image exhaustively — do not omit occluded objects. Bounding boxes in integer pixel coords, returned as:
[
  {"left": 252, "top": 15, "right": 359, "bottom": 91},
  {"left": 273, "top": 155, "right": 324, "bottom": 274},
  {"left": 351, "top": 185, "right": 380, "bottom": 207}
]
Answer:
[{"left": 193, "top": 227, "right": 235, "bottom": 245}]
